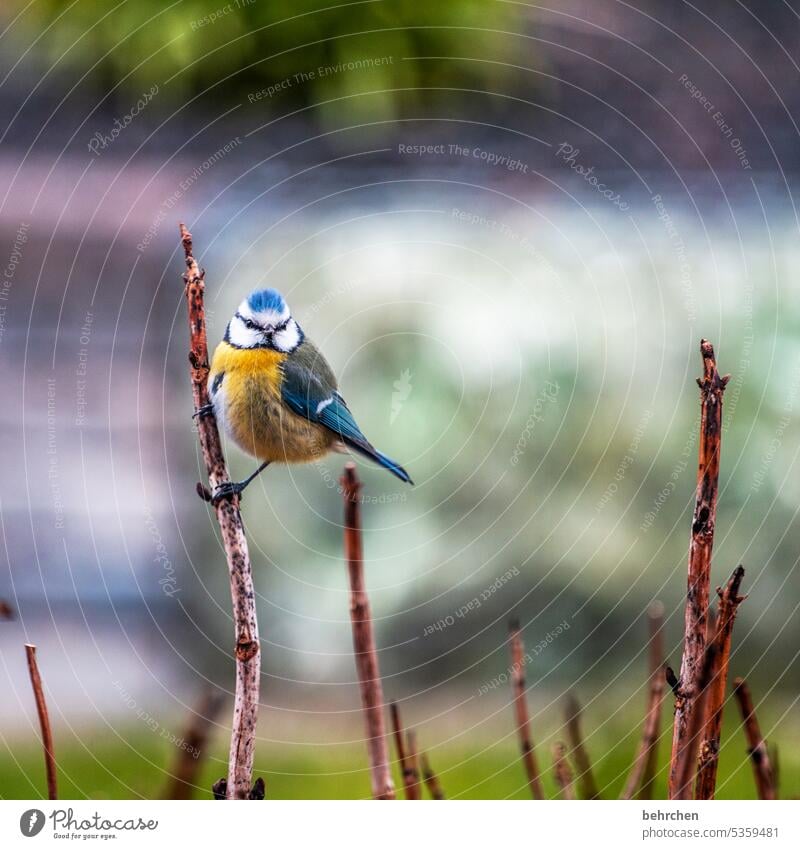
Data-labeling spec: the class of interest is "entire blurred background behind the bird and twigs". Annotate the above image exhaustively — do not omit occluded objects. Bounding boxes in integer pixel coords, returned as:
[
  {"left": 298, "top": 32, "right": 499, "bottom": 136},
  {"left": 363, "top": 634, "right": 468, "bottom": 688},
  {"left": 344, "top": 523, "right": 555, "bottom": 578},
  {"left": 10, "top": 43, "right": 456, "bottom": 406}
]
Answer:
[{"left": 0, "top": 0, "right": 800, "bottom": 798}]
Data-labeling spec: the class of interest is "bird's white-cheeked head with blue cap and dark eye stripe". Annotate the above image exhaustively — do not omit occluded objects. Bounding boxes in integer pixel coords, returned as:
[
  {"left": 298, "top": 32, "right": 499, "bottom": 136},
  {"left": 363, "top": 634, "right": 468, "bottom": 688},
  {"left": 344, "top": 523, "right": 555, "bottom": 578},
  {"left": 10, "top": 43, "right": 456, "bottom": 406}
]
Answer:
[{"left": 225, "top": 289, "right": 303, "bottom": 354}]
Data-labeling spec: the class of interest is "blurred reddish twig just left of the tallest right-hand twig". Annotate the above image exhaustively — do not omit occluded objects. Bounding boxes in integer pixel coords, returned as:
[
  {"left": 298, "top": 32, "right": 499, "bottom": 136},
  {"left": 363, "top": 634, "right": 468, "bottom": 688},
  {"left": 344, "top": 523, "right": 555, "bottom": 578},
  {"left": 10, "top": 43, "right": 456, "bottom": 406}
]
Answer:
[{"left": 620, "top": 601, "right": 664, "bottom": 799}]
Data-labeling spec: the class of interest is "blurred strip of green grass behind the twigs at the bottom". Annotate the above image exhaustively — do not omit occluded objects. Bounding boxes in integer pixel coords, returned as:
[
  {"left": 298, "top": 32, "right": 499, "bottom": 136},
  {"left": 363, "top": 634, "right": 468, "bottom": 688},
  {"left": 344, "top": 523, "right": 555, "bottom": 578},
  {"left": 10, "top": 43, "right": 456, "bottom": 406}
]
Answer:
[{"left": 0, "top": 709, "right": 800, "bottom": 799}]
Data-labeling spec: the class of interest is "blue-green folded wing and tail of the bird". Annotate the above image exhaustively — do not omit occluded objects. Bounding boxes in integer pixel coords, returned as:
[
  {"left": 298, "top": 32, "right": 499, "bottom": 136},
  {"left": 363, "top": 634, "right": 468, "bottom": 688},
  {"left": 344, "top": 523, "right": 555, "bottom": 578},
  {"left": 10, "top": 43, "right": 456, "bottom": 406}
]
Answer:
[{"left": 281, "top": 342, "right": 412, "bottom": 483}]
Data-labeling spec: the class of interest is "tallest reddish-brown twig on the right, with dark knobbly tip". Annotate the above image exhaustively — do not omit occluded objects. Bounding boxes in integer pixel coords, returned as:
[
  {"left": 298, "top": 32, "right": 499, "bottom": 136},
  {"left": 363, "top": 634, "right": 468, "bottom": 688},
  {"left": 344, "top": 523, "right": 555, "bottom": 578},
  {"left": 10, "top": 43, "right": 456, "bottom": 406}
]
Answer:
[{"left": 669, "top": 339, "right": 730, "bottom": 799}]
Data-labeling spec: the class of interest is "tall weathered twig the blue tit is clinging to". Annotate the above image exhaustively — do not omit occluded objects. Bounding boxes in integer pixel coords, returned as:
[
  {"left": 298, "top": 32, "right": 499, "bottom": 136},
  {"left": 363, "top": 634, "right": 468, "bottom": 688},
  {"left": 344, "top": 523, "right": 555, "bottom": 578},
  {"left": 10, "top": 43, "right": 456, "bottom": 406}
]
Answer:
[{"left": 180, "top": 224, "right": 261, "bottom": 799}]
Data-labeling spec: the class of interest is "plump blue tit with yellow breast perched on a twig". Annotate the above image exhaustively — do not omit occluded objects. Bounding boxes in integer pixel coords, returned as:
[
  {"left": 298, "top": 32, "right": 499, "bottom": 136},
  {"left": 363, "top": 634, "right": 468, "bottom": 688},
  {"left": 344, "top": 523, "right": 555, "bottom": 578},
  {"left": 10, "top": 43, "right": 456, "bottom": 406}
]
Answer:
[{"left": 205, "top": 289, "right": 413, "bottom": 502}]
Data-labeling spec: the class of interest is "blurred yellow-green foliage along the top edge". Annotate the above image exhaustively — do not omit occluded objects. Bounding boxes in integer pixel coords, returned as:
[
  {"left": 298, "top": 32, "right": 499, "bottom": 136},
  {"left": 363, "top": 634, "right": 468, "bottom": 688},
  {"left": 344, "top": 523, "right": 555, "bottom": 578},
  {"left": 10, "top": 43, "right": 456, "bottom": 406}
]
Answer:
[{"left": 10, "top": 0, "right": 527, "bottom": 120}]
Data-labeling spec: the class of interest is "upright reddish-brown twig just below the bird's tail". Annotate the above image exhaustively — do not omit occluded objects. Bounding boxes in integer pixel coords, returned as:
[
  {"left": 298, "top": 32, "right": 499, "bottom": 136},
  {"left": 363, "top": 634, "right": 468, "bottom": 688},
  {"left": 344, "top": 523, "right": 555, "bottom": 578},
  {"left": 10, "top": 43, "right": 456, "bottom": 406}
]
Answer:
[{"left": 341, "top": 463, "right": 395, "bottom": 799}]
